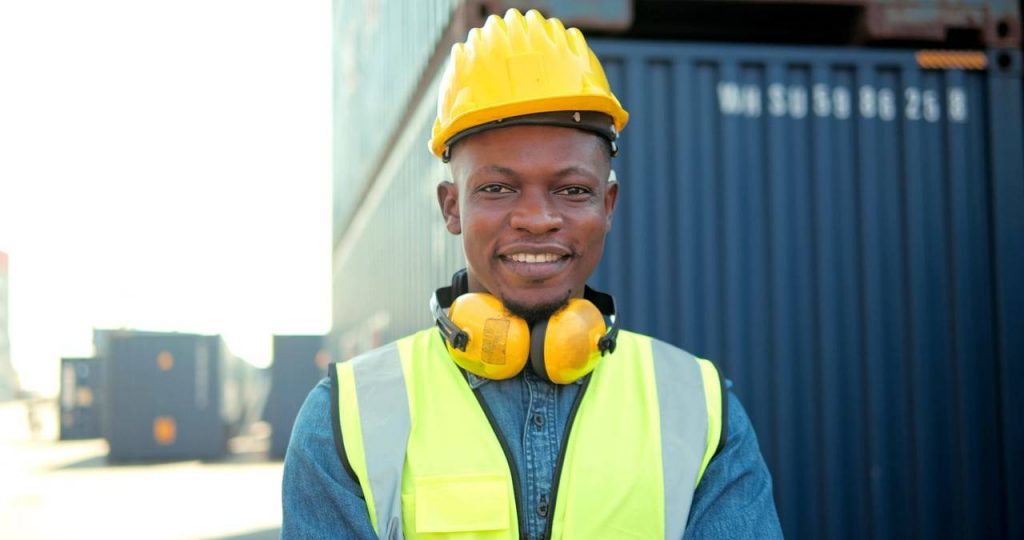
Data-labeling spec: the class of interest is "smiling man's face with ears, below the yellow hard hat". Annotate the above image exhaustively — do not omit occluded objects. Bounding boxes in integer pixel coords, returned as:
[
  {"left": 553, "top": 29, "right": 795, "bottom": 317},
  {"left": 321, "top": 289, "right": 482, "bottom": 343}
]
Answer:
[{"left": 437, "top": 126, "right": 618, "bottom": 315}]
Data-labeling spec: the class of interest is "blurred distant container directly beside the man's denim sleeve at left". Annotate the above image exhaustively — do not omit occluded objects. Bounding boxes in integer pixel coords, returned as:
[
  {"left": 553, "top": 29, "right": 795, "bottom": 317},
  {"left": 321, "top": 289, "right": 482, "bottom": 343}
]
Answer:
[{"left": 263, "top": 335, "right": 329, "bottom": 458}]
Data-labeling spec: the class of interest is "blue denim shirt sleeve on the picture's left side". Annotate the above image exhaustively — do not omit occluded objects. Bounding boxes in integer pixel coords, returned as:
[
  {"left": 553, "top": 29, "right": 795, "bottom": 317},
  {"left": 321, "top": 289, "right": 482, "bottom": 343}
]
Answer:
[{"left": 281, "top": 379, "right": 377, "bottom": 540}]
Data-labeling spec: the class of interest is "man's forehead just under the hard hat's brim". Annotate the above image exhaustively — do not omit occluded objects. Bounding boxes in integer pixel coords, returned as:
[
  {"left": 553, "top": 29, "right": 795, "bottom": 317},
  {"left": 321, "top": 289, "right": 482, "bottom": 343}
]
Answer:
[{"left": 451, "top": 126, "right": 609, "bottom": 179}]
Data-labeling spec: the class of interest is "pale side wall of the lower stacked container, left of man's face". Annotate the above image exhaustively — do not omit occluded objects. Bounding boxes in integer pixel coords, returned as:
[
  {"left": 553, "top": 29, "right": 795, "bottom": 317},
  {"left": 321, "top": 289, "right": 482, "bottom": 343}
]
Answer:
[{"left": 331, "top": 70, "right": 464, "bottom": 360}]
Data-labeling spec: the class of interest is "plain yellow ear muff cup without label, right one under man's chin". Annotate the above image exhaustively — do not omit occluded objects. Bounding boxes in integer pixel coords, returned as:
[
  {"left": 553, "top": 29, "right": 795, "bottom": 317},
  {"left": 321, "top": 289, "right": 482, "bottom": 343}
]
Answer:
[{"left": 535, "top": 298, "right": 607, "bottom": 384}]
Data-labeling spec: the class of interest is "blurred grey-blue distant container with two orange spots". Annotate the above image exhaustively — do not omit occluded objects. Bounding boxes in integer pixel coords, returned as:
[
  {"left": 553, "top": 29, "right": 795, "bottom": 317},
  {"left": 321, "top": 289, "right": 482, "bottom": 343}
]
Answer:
[{"left": 103, "top": 331, "right": 248, "bottom": 461}]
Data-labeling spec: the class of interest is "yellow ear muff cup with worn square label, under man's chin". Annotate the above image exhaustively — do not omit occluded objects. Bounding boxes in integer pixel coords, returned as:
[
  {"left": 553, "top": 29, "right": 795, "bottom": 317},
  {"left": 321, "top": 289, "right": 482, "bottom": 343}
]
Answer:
[{"left": 445, "top": 293, "right": 529, "bottom": 380}]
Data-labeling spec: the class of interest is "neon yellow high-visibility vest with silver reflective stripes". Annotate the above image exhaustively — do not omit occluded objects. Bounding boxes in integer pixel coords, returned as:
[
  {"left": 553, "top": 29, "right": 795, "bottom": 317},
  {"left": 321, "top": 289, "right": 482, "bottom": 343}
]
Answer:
[{"left": 329, "top": 329, "right": 726, "bottom": 540}]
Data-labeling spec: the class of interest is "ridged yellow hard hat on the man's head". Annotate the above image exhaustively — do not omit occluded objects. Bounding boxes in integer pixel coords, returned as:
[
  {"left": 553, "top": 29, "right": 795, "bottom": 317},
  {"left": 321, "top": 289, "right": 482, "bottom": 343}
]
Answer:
[{"left": 429, "top": 9, "right": 630, "bottom": 161}]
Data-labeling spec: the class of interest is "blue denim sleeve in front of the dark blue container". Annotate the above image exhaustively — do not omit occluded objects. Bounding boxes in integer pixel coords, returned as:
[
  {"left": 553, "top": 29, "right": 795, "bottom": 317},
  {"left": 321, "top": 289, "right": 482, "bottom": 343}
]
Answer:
[{"left": 683, "top": 391, "right": 782, "bottom": 540}]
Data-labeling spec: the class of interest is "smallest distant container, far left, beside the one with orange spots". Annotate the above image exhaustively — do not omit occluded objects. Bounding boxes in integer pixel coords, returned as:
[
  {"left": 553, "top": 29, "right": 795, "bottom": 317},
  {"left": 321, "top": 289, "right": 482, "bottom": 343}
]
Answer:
[{"left": 57, "top": 358, "right": 103, "bottom": 441}]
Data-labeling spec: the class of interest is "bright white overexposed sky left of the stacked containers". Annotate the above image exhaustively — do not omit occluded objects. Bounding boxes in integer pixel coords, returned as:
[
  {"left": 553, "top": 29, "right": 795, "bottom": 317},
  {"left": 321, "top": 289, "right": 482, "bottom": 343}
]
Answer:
[{"left": 0, "top": 0, "right": 332, "bottom": 393}]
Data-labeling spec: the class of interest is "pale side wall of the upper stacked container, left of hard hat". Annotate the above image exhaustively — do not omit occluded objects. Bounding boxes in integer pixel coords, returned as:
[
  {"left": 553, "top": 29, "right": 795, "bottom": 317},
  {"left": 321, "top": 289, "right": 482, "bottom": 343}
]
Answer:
[{"left": 333, "top": 0, "right": 462, "bottom": 242}]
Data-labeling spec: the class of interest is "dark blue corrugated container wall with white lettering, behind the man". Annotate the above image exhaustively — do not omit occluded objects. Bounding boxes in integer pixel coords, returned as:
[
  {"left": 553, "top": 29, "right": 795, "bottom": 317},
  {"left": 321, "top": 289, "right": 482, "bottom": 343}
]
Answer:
[{"left": 592, "top": 40, "right": 1024, "bottom": 539}]
